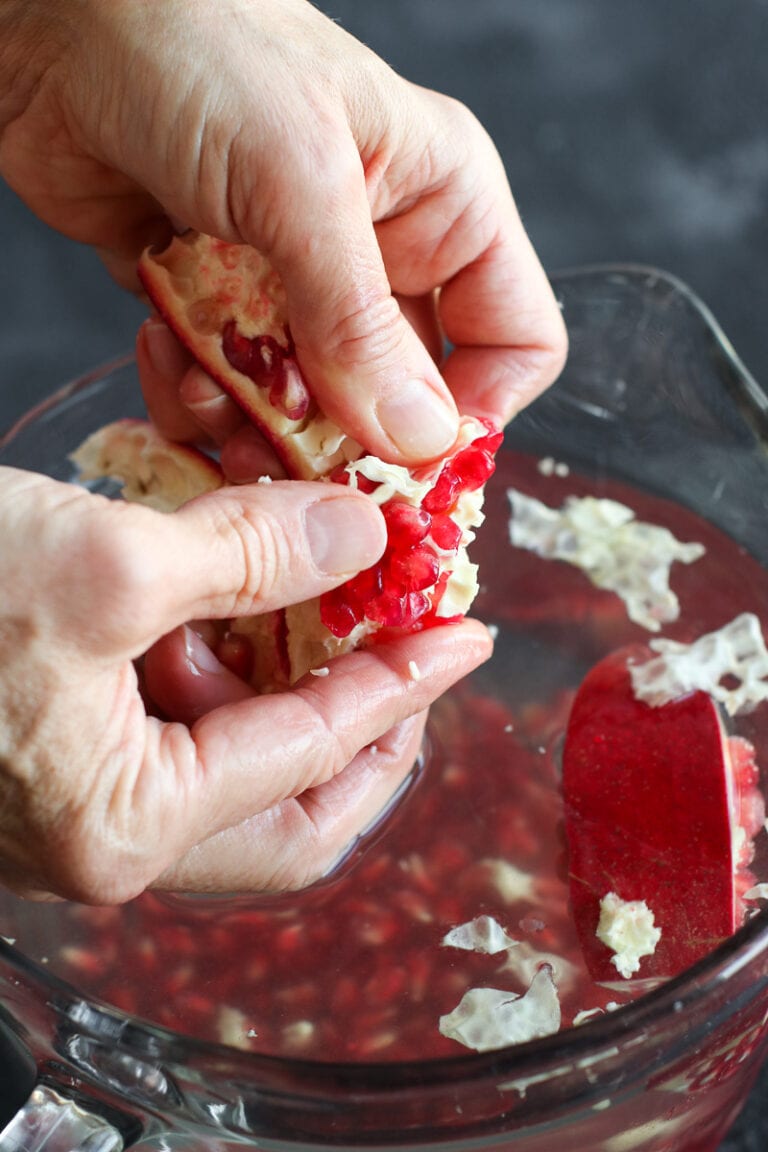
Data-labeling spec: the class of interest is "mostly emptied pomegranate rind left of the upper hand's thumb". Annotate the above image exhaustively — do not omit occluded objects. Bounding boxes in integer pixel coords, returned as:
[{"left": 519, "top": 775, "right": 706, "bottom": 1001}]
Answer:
[{"left": 138, "top": 232, "right": 363, "bottom": 480}]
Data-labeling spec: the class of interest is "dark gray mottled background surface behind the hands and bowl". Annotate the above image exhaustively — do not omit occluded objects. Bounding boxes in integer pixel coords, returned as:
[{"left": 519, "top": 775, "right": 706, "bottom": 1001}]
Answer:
[{"left": 0, "top": 0, "right": 768, "bottom": 1152}]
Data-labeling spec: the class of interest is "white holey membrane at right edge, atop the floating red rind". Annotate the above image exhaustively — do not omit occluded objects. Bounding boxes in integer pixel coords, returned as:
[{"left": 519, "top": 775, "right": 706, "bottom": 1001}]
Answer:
[{"left": 630, "top": 612, "right": 768, "bottom": 715}]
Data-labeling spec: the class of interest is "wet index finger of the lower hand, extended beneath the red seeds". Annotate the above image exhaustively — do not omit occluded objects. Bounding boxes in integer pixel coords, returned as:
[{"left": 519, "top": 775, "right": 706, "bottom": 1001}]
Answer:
[{"left": 130, "top": 621, "right": 492, "bottom": 893}]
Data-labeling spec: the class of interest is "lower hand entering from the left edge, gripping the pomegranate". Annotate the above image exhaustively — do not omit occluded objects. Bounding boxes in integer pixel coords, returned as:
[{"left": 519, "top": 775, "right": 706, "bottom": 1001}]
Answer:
[{"left": 0, "top": 468, "right": 491, "bottom": 904}]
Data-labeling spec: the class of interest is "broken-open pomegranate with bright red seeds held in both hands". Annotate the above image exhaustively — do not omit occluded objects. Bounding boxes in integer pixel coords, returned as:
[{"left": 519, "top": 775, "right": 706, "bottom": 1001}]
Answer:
[{"left": 75, "top": 233, "right": 502, "bottom": 689}]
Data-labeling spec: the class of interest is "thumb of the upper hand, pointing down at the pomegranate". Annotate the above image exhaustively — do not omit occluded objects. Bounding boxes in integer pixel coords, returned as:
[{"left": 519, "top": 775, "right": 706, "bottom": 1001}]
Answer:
[{"left": 268, "top": 137, "right": 458, "bottom": 464}]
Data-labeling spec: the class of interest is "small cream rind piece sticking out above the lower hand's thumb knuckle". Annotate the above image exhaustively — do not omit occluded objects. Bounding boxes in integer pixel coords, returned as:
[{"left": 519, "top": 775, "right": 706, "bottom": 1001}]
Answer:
[{"left": 70, "top": 419, "right": 225, "bottom": 511}]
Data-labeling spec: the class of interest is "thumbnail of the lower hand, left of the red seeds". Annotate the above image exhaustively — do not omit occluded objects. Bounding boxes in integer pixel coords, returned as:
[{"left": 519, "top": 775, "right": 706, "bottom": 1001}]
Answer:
[{"left": 305, "top": 497, "right": 387, "bottom": 576}]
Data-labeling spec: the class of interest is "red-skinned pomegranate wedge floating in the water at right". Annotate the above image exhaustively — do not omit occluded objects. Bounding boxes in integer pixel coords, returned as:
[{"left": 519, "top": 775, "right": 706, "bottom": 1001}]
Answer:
[{"left": 563, "top": 645, "right": 765, "bottom": 982}]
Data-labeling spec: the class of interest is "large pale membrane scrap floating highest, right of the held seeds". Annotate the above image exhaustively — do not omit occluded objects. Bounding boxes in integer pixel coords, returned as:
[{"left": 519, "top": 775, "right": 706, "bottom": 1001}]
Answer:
[{"left": 507, "top": 488, "right": 705, "bottom": 632}]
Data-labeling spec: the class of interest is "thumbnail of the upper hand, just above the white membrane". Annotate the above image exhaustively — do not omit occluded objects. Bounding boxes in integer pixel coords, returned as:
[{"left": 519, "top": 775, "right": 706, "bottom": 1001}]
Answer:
[{"left": 377, "top": 380, "right": 458, "bottom": 460}]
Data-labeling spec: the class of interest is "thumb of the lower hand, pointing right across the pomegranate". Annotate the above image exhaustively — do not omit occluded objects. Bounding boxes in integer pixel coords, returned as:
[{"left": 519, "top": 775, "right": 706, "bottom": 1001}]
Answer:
[{"left": 38, "top": 472, "right": 387, "bottom": 666}]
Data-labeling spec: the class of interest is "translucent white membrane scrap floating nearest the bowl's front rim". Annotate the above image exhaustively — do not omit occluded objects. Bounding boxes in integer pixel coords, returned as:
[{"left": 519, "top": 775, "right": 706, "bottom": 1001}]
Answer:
[{"left": 439, "top": 965, "right": 561, "bottom": 1052}]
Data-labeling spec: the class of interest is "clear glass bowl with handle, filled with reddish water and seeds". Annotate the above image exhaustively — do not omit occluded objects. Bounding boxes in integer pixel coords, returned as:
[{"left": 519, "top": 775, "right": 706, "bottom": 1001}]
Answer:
[{"left": 0, "top": 266, "right": 768, "bottom": 1152}]
